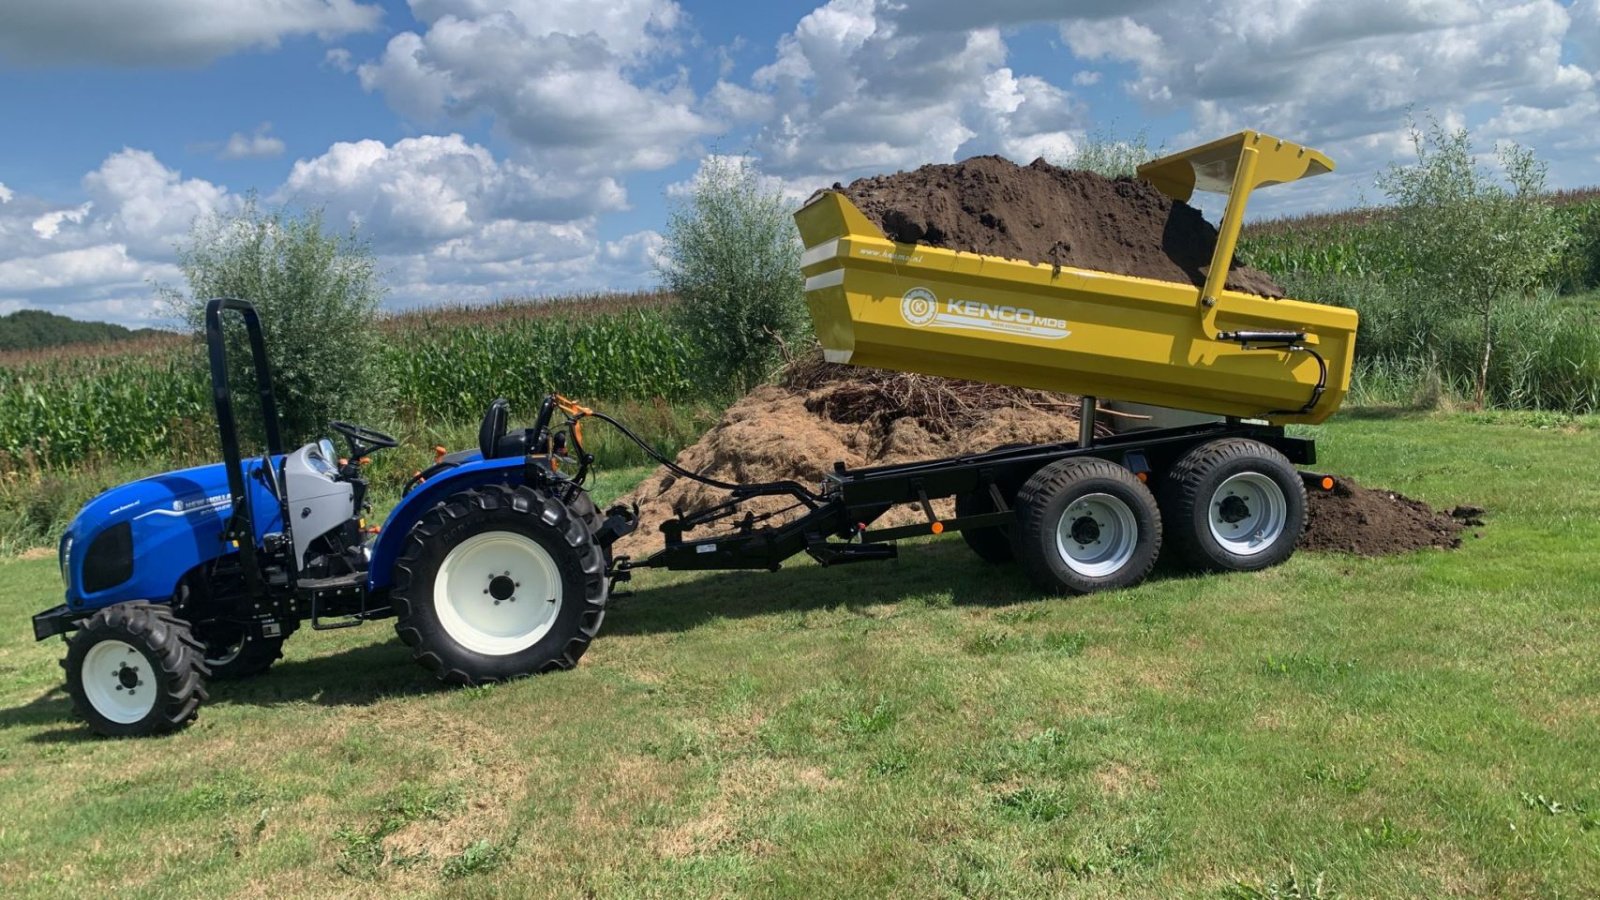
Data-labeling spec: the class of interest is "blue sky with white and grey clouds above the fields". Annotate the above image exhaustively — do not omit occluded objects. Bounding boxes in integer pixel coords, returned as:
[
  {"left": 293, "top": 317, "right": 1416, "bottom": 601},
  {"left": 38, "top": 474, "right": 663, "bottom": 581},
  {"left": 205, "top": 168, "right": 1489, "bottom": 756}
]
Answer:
[{"left": 0, "top": 0, "right": 1600, "bottom": 323}]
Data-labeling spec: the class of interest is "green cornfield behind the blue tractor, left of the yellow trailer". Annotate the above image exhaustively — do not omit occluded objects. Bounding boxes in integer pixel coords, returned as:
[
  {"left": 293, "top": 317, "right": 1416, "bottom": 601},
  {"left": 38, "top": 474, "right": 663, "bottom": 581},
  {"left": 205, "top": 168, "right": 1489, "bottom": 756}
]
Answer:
[{"left": 0, "top": 295, "right": 700, "bottom": 472}]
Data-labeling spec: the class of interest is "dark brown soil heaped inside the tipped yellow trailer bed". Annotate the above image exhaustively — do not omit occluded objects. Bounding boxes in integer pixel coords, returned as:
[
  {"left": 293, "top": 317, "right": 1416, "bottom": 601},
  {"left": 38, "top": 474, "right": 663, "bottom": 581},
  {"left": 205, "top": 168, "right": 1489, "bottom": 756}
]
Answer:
[{"left": 834, "top": 157, "right": 1283, "bottom": 298}]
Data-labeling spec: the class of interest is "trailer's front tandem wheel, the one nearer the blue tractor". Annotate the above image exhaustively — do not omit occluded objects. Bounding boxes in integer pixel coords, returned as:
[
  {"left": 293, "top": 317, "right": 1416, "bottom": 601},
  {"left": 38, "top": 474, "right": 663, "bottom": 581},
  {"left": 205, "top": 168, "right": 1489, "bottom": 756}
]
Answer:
[{"left": 1014, "top": 458, "right": 1162, "bottom": 594}]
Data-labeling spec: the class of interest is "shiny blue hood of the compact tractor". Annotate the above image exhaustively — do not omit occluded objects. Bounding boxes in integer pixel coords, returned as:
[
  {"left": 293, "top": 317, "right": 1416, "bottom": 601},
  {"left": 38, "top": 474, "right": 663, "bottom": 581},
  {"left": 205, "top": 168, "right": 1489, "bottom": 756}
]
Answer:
[{"left": 61, "top": 460, "right": 283, "bottom": 610}]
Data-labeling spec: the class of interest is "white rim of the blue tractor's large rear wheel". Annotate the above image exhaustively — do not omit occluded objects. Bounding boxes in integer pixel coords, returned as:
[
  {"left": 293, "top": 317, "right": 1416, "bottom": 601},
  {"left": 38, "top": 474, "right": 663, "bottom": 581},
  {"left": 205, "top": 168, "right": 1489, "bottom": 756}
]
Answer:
[{"left": 434, "top": 532, "right": 563, "bottom": 657}]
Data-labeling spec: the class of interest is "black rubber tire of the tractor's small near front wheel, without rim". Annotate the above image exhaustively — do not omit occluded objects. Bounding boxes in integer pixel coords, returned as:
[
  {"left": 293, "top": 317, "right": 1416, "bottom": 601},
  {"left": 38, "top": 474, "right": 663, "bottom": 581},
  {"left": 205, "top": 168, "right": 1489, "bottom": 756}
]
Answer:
[{"left": 66, "top": 601, "right": 211, "bottom": 737}]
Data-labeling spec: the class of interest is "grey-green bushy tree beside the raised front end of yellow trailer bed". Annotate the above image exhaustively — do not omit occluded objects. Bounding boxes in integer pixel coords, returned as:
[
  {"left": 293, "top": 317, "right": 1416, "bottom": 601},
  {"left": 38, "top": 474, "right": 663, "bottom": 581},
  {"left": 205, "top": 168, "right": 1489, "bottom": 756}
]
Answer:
[{"left": 661, "top": 155, "right": 808, "bottom": 391}]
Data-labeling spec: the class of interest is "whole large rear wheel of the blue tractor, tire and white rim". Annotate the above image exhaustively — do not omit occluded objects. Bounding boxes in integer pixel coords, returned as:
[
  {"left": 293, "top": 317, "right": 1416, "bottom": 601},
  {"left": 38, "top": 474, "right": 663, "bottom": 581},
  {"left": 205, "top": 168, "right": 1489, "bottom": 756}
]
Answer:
[{"left": 390, "top": 485, "right": 608, "bottom": 685}]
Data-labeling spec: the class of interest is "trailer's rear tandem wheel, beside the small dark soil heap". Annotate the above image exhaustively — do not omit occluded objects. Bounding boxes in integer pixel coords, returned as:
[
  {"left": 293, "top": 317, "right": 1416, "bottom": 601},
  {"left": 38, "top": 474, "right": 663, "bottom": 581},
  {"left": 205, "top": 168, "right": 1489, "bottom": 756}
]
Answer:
[{"left": 1162, "top": 437, "right": 1306, "bottom": 572}]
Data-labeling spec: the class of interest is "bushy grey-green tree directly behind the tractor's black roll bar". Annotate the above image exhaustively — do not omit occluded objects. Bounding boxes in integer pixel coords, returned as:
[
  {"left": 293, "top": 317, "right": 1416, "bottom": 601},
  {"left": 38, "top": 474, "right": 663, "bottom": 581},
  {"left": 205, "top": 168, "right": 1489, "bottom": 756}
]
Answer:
[{"left": 157, "top": 197, "right": 386, "bottom": 444}]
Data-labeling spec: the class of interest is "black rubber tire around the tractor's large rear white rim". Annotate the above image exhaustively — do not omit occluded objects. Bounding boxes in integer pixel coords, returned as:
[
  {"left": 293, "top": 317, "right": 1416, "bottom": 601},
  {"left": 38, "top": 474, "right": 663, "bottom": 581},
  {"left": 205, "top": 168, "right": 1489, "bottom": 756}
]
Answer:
[{"left": 389, "top": 485, "right": 608, "bottom": 687}]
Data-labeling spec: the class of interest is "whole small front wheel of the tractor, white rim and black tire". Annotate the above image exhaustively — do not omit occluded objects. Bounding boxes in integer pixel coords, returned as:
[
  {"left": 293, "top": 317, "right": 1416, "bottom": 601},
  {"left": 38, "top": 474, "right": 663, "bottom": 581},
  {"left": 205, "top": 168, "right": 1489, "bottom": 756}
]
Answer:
[{"left": 62, "top": 601, "right": 206, "bottom": 737}]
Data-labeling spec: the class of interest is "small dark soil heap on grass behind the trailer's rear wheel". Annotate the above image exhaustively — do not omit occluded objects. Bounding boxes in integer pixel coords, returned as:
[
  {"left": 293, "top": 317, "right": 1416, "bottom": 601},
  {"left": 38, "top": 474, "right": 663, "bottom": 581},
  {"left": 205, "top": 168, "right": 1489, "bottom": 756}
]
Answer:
[{"left": 1299, "top": 479, "right": 1483, "bottom": 556}]
